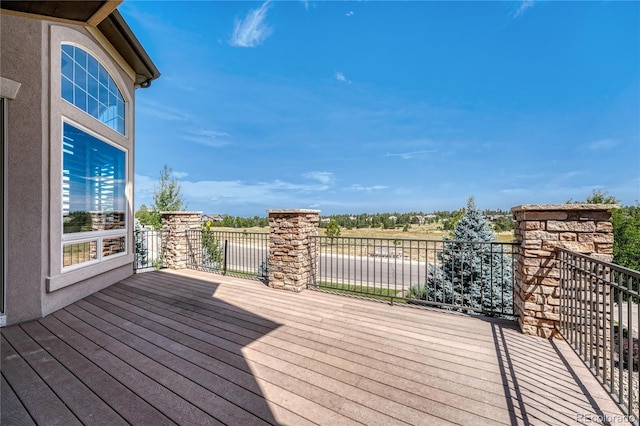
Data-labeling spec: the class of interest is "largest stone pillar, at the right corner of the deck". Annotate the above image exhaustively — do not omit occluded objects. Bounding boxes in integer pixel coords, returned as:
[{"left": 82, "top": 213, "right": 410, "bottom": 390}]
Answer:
[{"left": 511, "top": 204, "right": 617, "bottom": 338}]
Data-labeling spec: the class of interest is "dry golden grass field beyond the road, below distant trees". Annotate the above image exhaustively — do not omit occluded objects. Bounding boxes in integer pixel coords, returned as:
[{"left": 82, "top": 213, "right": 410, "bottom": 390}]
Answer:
[{"left": 213, "top": 224, "right": 513, "bottom": 243}]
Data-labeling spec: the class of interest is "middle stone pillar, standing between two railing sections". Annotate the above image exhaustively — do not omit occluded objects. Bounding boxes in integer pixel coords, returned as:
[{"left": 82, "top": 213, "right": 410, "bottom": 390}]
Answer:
[{"left": 267, "top": 209, "right": 320, "bottom": 292}]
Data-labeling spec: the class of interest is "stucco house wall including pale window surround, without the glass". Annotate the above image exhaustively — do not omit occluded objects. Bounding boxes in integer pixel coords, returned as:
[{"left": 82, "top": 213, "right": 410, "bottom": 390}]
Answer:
[{"left": 0, "top": 13, "right": 139, "bottom": 324}]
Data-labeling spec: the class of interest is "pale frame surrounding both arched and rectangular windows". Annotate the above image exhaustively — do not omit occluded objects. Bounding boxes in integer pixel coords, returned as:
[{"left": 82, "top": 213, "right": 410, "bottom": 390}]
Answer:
[{"left": 47, "top": 24, "right": 136, "bottom": 293}]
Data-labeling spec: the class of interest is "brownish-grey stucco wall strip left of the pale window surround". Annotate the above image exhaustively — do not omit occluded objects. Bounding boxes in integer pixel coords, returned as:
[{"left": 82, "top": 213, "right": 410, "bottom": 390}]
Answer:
[{"left": 0, "top": 15, "right": 49, "bottom": 322}]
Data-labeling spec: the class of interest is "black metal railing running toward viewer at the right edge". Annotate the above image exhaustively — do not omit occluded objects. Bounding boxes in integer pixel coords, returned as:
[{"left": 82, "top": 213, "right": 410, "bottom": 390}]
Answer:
[{"left": 558, "top": 249, "right": 640, "bottom": 424}]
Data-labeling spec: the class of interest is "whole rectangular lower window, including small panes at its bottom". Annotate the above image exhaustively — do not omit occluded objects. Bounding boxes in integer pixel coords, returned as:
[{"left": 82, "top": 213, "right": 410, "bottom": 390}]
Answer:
[{"left": 62, "top": 122, "right": 127, "bottom": 267}]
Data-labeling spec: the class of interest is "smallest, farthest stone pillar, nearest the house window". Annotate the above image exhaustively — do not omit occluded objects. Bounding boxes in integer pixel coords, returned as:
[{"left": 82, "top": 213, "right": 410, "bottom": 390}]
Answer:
[{"left": 161, "top": 212, "right": 202, "bottom": 269}]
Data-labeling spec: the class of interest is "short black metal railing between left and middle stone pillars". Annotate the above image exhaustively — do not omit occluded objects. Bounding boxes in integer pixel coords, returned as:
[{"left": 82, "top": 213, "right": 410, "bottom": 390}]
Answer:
[{"left": 186, "top": 228, "right": 269, "bottom": 281}]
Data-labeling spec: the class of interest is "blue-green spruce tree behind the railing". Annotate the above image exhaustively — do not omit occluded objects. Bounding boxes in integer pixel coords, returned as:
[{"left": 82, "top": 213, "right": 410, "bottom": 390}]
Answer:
[{"left": 425, "top": 197, "right": 513, "bottom": 313}]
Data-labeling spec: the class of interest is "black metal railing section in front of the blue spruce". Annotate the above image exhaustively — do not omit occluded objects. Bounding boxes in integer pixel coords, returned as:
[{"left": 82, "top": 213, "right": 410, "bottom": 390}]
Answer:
[{"left": 309, "top": 236, "right": 514, "bottom": 316}]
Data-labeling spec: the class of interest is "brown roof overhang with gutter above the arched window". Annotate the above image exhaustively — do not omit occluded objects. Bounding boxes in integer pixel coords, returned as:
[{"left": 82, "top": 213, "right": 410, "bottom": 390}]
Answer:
[{"left": 0, "top": 0, "right": 160, "bottom": 87}]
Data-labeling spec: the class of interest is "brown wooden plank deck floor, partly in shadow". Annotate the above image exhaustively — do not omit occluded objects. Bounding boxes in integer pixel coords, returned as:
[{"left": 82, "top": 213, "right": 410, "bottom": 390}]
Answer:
[{"left": 0, "top": 271, "right": 622, "bottom": 426}]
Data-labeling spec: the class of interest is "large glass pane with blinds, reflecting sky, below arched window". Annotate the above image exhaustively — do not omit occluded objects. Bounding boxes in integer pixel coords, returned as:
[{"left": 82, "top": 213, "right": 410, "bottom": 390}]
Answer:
[{"left": 62, "top": 123, "right": 126, "bottom": 234}]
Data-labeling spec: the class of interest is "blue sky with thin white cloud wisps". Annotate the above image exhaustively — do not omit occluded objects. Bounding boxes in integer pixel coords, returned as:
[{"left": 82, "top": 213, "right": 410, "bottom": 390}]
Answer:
[{"left": 119, "top": 0, "right": 640, "bottom": 216}]
